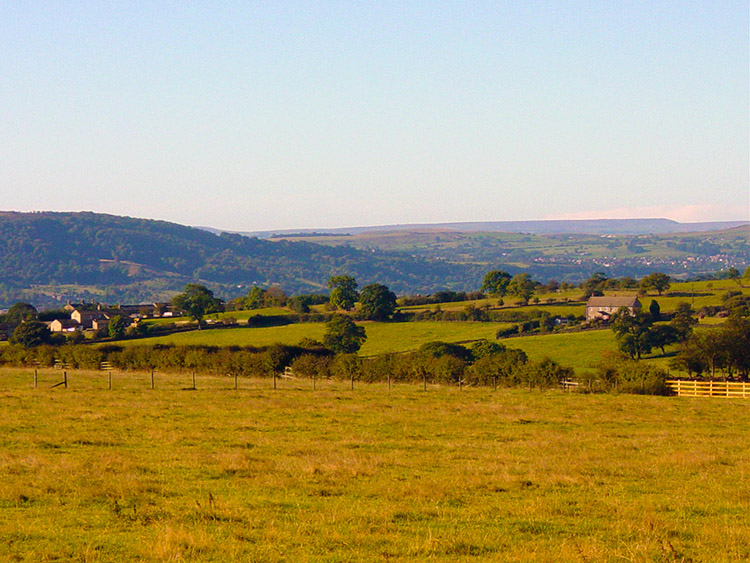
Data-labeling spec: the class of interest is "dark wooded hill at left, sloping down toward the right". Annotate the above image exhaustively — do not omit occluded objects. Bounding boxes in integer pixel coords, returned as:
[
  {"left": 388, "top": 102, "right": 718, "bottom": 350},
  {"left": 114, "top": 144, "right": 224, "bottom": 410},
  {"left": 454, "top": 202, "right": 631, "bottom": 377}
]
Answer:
[{"left": 0, "top": 212, "right": 482, "bottom": 306}]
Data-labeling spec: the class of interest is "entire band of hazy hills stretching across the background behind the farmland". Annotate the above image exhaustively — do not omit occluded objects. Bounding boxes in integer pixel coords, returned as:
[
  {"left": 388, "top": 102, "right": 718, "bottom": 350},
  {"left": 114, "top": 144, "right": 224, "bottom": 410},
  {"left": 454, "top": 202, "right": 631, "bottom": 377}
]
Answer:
[{"left": 0, "top": 212, "right": 750, "bottom": 308}]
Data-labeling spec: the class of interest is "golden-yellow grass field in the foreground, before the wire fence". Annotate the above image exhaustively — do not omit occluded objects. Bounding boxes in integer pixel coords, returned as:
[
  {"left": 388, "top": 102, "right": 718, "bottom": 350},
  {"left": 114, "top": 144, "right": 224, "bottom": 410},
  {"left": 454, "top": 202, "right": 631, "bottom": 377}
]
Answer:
[{"left": 0, "top": 371, "right": 750, "bottom": 562}]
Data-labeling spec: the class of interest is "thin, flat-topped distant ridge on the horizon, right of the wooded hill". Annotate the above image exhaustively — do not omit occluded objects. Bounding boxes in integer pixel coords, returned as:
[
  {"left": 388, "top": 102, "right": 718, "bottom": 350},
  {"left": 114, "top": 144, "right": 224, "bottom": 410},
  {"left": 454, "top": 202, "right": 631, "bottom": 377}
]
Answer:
[{"left": 209, "top": 219, "right": 750, "bottom": 238}]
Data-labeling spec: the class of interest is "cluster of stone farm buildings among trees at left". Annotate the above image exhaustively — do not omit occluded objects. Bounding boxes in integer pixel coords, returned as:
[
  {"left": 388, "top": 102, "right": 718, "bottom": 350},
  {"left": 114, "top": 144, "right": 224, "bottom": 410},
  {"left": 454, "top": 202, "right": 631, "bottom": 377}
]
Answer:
[{"left": 49, "top": 303, "right": 173, "bottom": 332}]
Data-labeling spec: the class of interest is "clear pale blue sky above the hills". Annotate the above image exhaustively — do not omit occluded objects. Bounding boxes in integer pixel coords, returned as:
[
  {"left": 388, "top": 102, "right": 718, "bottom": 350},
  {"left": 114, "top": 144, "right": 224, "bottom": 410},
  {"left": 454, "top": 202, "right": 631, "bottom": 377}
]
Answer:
[{"left": 0, "top": 0, "right": 750, "bottom": 230}]
